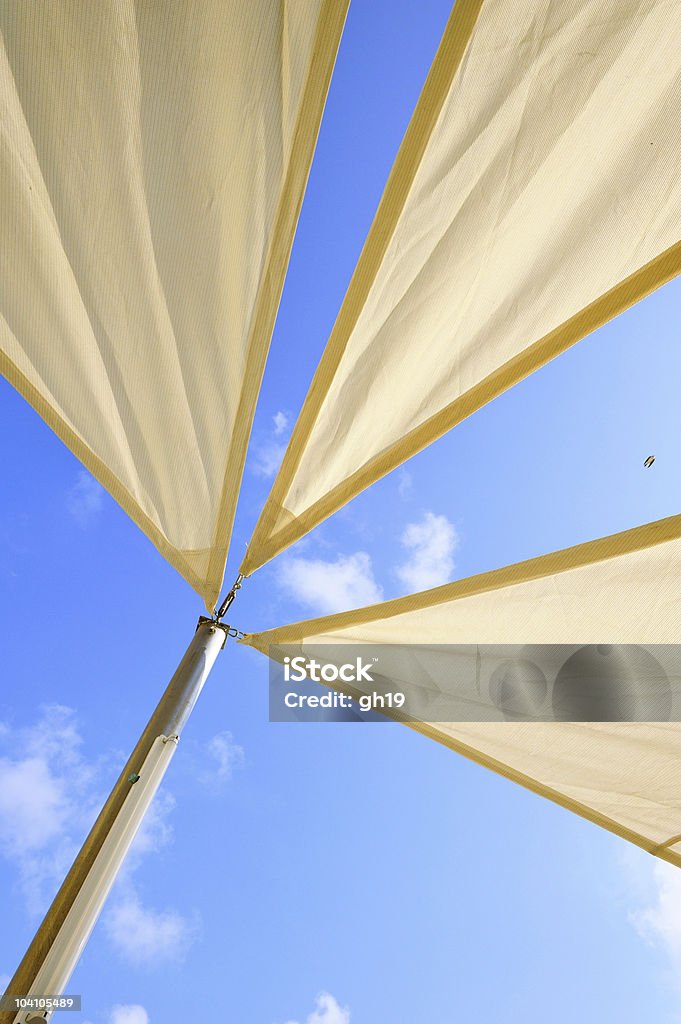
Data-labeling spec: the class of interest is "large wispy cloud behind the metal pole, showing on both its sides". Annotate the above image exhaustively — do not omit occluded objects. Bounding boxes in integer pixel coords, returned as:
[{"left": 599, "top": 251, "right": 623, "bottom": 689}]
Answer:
[{"left": 0, "top": 705, "right": 206, "bottom": 965}]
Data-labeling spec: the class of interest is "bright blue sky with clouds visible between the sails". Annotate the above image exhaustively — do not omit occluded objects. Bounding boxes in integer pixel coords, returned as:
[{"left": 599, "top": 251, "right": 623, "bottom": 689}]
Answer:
[{"left": 0, "top": 0, "right": 681, "bottom": 1024}]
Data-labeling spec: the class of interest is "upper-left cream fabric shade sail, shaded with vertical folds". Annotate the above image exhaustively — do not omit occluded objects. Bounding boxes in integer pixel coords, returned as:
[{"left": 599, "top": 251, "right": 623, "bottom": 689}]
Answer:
[{"left": 0, "top": 0, "right": 347, "bottom": 607}]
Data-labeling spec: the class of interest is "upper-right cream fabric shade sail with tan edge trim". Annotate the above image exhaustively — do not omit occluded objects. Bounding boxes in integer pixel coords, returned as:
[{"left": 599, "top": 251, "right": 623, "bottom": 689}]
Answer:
[{"left": 242, "top": 0, "right": 681, "bottom": 573}]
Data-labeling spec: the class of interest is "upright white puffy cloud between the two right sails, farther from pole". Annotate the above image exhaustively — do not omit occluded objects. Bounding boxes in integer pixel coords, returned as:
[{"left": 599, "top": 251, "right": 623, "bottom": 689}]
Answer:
[{"left": 395, "top": 512, "right": 459, "bottom": 591}]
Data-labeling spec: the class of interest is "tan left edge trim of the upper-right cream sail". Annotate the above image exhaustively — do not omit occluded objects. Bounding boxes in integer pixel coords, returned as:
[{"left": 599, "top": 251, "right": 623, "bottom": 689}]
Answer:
[{"left": 240, "top": 0, "right": 483, "bottom": 575}]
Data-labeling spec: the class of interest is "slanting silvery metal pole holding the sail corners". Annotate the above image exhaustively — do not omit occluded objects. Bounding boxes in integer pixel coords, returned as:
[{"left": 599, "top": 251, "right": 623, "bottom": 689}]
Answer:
[{"left": 0, "top": 617, "right": 229, "bottom": 1024}]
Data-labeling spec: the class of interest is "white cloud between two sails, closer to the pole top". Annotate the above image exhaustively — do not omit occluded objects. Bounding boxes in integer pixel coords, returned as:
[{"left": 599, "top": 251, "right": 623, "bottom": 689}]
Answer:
[{"left": 279, "top": 551, "right": 383, "bottom": 614}]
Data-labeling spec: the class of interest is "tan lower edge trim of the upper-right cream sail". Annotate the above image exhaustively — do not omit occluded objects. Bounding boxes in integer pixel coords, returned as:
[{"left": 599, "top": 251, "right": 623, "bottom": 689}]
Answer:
[{"left": 241, "top": 242, "right": 681, "bottom": 575}]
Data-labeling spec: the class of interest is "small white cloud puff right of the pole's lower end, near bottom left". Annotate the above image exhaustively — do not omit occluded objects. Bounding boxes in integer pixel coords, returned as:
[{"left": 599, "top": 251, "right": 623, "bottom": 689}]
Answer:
[{"left": 103, "top": 891, "right": 197, "bottom": 967}]
